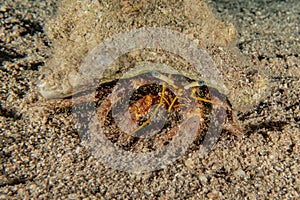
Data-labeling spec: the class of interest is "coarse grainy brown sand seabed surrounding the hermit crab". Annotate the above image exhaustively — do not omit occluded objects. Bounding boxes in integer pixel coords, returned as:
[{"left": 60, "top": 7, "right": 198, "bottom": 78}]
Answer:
[{"left": 0, "top": 0, "right": 300, "bottom": 199}]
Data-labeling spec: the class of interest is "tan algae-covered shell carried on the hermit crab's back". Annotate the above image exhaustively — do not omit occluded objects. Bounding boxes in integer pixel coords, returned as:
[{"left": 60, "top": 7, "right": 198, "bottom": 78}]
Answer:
[{"left": 38, "top": 0, "right": 236, "bottom": 98}]
